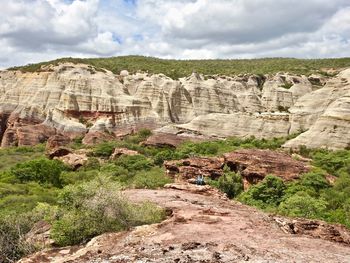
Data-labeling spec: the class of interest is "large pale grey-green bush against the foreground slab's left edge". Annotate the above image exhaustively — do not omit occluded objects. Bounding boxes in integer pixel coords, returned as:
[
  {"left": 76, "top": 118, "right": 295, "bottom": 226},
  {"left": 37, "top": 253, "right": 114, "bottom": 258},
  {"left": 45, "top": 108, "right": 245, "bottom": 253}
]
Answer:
[{"left": 51, "top": 177, "right": 165, "bottom": 246}]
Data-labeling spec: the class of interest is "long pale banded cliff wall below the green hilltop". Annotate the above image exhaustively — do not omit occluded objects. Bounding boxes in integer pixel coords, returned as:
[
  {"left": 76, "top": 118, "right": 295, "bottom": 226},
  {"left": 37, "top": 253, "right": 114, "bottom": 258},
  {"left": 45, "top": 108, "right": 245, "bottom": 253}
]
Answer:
[{"left": 0, "top": 63, "right": 350, "bottom": 149}]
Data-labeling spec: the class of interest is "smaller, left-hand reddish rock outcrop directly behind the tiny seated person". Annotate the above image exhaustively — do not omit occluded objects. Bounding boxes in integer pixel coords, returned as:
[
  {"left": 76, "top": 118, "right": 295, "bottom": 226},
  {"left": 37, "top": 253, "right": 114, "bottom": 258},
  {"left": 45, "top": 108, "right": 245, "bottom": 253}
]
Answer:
[{"left": 164, "top": 157, "right": 224, "bottom": 181}]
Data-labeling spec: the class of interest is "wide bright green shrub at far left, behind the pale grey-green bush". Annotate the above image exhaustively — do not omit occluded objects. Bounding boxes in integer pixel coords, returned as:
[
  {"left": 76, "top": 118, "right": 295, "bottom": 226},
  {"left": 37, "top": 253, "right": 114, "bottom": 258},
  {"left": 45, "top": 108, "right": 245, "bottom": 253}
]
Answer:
[{"left": 11, "top": 158, "right": 67, "bottom": 187}]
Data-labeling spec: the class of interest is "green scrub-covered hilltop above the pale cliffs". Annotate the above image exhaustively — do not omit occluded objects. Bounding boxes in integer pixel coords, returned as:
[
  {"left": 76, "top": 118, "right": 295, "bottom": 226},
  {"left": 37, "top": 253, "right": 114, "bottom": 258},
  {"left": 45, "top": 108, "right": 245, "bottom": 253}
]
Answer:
[{"left": 10, "top": 56, "right": 350, "bottom": 79}]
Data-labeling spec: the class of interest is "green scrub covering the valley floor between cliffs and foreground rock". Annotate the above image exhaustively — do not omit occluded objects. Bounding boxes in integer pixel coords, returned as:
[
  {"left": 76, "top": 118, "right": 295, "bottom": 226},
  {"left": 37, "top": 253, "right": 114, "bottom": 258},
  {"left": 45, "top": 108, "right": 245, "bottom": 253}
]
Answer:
[{"left": 0, "top": 130, "right": 350, "bottom": 262}]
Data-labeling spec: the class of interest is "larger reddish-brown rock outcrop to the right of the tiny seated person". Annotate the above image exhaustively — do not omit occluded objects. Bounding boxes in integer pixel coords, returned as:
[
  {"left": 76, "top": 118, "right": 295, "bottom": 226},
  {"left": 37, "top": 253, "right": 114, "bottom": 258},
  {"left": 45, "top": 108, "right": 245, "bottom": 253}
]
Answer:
[{"left": 224, "top": 149, "right": 309, "bottom": 189}]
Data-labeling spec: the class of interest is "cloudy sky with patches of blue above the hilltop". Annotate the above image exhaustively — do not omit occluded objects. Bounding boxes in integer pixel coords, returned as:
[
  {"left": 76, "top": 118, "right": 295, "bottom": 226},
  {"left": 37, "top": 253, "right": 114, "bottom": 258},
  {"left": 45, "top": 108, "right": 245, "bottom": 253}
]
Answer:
[{"left": 0, "top": 0, "right": 350, "bottom": 68}]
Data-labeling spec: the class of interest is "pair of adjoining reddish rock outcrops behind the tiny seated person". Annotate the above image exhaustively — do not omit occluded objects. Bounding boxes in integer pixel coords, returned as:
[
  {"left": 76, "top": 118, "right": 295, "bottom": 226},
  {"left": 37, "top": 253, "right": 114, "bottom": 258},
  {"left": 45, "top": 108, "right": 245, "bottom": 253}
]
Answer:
[{"left": 164, "top": 149, "right": 310, "bottom": 189}]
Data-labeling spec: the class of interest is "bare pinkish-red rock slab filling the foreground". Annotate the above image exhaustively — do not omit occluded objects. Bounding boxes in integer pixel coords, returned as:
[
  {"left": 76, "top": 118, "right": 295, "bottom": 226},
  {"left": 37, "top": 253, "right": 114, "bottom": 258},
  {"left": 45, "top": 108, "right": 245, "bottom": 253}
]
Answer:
[{"left": 20, "top": 184, "right": 350, "bottom": 263}]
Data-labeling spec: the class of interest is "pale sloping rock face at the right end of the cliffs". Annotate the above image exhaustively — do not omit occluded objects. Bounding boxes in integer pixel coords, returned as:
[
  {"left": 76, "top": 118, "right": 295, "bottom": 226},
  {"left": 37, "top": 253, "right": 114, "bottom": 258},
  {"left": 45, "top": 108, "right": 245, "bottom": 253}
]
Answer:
[{"left": 284, "top": 69, "right": 350, "bottom": 149}]
